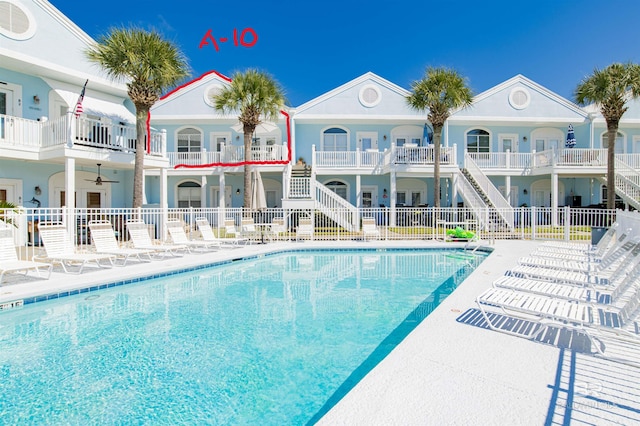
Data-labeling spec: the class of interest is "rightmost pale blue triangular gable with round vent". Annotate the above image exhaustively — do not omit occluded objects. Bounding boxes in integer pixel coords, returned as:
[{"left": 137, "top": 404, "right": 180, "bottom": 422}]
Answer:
[{"left": 451, "top": 74, "right": 589, "bottom": 122}]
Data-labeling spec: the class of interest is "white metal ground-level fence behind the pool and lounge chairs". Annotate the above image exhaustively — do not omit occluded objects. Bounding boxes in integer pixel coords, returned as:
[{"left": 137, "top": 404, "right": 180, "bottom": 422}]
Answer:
[{"left": 0, "top": 207, "right": 620, "bottom": 259}]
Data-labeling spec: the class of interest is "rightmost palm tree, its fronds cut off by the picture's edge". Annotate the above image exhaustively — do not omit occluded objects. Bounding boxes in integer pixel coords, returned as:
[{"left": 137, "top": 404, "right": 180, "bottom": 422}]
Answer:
[{"left": 575, "top": 63, "right": 640, "bottom": 209}]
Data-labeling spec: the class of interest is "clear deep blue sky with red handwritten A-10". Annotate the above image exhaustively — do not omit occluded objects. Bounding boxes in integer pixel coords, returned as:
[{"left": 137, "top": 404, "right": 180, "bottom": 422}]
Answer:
[{"left": 51, "top": 0, "right": 640, "bottom": 106}]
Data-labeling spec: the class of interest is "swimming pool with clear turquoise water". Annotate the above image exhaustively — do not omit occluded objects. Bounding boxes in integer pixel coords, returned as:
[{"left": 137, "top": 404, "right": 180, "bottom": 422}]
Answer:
[{"left": 0, "top": 249, "right": 486, "bottom": 424}]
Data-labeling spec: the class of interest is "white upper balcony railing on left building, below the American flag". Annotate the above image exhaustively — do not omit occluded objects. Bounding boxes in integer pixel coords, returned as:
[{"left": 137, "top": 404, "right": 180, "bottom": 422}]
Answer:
[{"left": 0, "top": 114, "right": 166, "bottom": 159}]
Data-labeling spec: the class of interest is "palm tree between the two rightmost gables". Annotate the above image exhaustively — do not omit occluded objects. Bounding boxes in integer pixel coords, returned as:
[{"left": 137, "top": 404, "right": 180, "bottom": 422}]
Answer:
[{"left": 407, "top": 67, "right": 473, "bottom": 208}]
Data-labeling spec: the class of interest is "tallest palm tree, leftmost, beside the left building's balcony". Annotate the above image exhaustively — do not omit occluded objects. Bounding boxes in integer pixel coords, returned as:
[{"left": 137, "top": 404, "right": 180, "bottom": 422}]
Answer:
[{"left": 85, "top": 28, "right": 190, "bottom": 208}]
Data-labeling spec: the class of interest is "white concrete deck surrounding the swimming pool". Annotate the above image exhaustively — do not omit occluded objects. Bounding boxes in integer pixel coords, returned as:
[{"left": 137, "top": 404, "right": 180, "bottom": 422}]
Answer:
[{"left": 0, "top": 240, "right": 640, "bottom": 425}]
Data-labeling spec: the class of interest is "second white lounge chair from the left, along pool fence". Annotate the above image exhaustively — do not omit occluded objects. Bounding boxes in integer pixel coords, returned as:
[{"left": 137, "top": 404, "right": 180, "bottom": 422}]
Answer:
[{"left": 34, "top": 222, "right": 115, "bottom": 274}]
